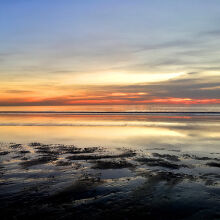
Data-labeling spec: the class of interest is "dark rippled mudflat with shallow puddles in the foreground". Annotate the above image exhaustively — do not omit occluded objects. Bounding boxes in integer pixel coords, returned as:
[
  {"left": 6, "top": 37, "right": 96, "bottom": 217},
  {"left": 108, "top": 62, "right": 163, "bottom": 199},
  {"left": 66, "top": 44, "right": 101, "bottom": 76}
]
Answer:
[{"left": 0, "top": 142, "right": 220, "bottom": 220}]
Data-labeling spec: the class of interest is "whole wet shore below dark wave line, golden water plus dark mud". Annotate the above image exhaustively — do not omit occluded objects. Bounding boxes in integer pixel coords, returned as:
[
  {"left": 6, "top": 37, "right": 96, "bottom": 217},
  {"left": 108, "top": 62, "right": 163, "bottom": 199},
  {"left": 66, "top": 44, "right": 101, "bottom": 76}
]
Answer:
[{"left": 0, "top": 113, "right": 220, "bottom": 220}]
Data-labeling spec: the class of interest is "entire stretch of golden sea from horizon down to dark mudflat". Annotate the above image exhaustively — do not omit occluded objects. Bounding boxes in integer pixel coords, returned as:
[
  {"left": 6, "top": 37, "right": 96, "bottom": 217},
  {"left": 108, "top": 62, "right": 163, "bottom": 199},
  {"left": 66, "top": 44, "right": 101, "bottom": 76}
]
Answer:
[{"left": 0, "top": 105, "right": 220, "bottom": 151}]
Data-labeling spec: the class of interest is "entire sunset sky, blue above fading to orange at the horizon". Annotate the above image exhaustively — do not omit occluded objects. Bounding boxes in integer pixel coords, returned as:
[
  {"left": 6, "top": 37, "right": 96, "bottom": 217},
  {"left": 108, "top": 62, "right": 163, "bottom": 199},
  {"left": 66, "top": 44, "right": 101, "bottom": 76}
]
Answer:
[{"left": 0, "top": 0, "right": 220, "bottom": 106}]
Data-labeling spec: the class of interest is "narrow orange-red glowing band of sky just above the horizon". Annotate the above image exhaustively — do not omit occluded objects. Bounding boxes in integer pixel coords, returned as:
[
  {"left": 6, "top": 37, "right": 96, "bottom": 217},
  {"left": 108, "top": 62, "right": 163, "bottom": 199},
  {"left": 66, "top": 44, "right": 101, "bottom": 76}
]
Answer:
[{"left": 0, "top": 93, "right": 220, "bottom": 106}]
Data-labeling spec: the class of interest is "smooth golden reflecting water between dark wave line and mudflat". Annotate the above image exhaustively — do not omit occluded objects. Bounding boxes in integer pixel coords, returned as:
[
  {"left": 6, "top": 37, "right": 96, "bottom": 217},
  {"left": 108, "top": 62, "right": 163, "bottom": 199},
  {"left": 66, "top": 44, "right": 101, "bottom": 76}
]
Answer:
[{"left": 0, "top": 114, "right": 220, "bottom": 151}]
